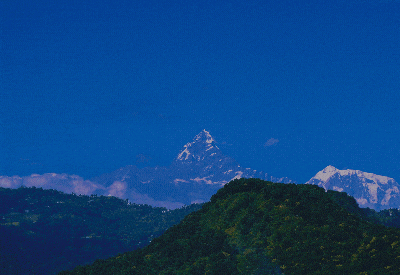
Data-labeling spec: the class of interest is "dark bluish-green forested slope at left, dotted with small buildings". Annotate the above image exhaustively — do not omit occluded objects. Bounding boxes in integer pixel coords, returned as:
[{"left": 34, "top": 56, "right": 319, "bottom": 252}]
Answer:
[{"left": 0, "top": 188, "right": 201, "bottom": 275}]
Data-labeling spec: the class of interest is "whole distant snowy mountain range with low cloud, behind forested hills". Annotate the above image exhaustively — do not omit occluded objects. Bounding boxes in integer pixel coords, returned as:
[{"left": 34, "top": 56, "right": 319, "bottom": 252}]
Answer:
[{"left": 0, "top": 130, "right": 400, "bottom": 210}]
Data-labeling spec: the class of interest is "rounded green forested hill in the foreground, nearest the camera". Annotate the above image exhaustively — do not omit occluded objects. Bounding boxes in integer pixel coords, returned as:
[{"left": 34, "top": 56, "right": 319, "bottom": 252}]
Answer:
[{"left": 60, "top": 179, "right": 400, "bottom": 275}]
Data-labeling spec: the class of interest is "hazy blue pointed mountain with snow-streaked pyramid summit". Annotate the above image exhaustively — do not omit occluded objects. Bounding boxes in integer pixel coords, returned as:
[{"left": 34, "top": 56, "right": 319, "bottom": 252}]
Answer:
[{"left": 92, "top": 130, "right": 292, "bottom": 208}]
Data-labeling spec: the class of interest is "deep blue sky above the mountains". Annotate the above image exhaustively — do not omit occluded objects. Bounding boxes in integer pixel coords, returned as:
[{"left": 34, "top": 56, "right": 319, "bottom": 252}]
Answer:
[{"left": 0, "top": 0, "right": 400, "bottom": 182}]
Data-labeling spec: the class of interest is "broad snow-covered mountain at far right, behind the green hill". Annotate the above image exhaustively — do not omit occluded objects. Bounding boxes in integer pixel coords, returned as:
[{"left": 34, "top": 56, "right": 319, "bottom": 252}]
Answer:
[{"left": 306, "top": 166, "right": 400, "bottom": 211}]
